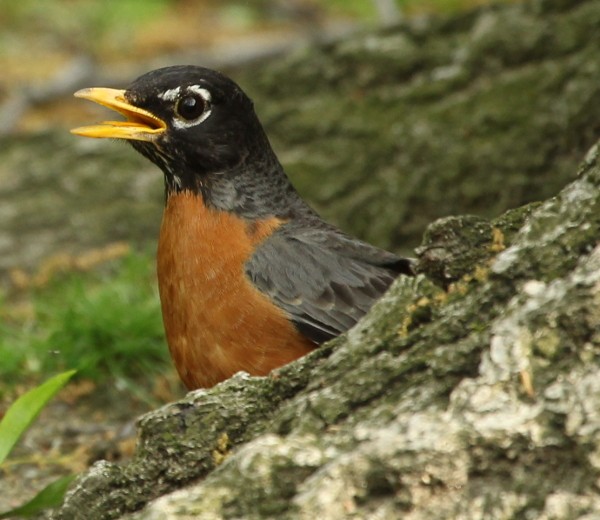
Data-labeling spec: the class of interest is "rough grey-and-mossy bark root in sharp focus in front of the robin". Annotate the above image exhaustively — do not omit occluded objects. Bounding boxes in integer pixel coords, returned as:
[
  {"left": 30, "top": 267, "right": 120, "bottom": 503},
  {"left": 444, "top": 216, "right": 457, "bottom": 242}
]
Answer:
[{"left": 56, "top": 139, "right": 600, "bottom": 519}]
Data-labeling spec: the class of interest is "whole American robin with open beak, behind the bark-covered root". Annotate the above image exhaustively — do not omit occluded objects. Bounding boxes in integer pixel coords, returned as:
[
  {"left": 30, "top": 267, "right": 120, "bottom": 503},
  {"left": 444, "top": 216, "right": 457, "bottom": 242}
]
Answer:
[{"left": 72, "top": 66, "right": 412, "bottom": 389}]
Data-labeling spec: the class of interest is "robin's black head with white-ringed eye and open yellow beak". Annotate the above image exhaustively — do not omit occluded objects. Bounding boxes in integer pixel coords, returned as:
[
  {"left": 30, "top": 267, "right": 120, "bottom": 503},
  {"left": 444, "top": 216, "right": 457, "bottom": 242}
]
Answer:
[{"left": 71, "top": 66, "right": 278, "bottom": 196}]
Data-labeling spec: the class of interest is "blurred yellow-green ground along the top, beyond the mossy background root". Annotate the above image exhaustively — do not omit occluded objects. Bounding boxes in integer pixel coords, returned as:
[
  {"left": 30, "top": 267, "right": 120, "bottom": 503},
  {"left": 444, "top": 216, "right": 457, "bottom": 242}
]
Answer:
[{"left": 0, "top": 0, "right": 500, "bottom": 134}]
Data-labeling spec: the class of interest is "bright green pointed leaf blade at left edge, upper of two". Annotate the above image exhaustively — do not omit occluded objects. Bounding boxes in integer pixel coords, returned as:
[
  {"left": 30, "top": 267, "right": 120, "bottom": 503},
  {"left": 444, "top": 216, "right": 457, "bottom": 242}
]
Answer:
[{"left": 0, "top": 370, "right": 76, "bottom": 464}]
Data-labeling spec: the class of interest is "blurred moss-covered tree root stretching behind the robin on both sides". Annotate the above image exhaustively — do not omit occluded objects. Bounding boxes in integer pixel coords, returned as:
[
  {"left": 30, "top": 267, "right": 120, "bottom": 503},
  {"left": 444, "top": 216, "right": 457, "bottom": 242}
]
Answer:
[{"left": 0, "top": 0, "right": 600, "bottom": 280}]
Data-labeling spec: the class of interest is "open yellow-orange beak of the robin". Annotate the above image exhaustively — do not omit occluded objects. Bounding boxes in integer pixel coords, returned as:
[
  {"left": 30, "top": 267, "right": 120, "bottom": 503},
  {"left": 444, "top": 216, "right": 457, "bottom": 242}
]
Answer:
[{"left": 71, "top": 88, "right": 167, "bottom": 142}]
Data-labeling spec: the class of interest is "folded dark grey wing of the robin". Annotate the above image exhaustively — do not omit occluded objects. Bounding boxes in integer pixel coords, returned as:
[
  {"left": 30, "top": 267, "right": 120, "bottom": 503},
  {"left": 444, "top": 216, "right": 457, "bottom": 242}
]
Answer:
[{"left": 246, "top": 230, "right": 412, "bottom": 344}]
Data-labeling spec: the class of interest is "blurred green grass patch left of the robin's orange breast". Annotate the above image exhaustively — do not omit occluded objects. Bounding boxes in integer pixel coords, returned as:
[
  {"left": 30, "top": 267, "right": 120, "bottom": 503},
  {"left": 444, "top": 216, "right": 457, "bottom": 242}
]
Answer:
[{"left": 0, "top": 253, "right": 169, "bottom": 384}]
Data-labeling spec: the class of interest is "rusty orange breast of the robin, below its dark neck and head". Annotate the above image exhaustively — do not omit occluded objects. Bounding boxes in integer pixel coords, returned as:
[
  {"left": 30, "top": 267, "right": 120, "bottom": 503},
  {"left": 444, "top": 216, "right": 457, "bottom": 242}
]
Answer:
[{"left": 157, "top": 192, "right": 315, "bottom": 389}]
